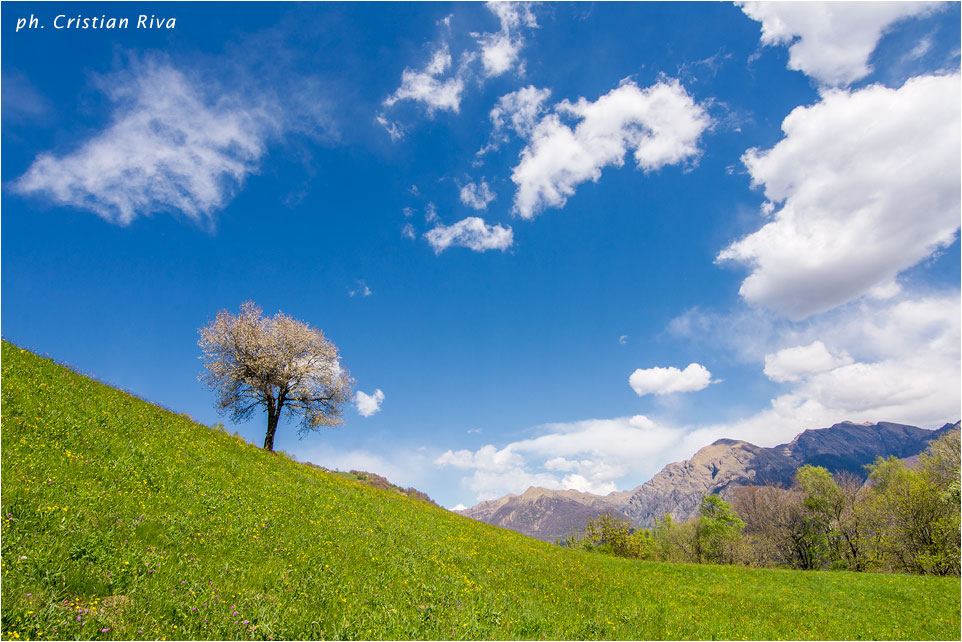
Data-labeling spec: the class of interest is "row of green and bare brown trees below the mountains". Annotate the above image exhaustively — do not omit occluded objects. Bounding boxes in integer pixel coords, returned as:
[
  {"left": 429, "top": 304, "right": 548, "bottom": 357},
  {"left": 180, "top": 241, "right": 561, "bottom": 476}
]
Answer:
[{"left": 562, "top": 430, "right": 962, "bottom": 575}]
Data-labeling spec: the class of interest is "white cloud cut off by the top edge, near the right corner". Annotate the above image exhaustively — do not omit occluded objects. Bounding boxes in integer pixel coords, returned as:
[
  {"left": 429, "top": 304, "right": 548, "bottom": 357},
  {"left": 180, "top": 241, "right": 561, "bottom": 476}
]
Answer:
[{"left": 741, "top": 2, "right": 944, "bottom": 86}]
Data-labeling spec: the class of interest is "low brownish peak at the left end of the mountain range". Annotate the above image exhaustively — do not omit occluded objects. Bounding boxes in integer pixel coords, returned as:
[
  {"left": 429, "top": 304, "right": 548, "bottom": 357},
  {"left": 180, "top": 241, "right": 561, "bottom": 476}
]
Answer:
[{"left": 457, "top": 487, "right": 628, "bottom": 542}]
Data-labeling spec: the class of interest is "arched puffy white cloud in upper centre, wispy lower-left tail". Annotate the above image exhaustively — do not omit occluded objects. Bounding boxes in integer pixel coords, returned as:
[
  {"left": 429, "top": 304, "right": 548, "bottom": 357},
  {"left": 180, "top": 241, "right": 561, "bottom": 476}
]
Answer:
[{"left": 511, "top": 80, "right": 711, "bottom": 219}]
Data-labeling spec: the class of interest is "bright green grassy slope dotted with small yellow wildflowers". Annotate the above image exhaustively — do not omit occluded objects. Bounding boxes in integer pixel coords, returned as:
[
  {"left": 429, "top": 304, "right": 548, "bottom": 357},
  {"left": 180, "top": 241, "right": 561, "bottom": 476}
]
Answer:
[{"left": 2, "top": 342, "right": 960, "bottom": 639}]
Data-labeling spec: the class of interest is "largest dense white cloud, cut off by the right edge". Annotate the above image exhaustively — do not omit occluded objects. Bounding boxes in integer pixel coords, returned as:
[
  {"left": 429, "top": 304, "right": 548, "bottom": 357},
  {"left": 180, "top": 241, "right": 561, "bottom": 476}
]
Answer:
[{"left": 718, "top": 74, "right": 962, "bottom": 319}]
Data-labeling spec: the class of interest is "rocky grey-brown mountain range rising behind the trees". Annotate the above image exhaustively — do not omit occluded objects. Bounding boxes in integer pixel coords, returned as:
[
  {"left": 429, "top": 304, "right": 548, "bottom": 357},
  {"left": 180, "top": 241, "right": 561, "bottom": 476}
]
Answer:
[{"left": 457, "top": 421, "right": 959, "bottom": 541}]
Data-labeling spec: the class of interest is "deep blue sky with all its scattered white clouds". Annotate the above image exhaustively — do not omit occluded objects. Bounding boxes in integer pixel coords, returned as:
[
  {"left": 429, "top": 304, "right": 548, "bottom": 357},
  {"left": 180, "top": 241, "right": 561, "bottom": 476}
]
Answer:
[{"left": 0, "top": 2, "right": 962, "bottom": 506}]
